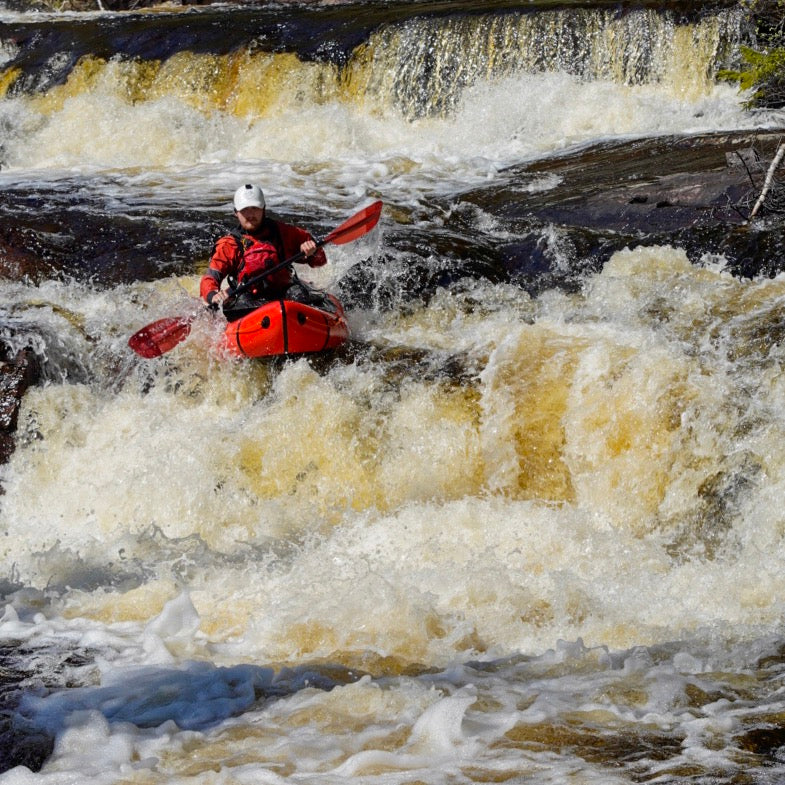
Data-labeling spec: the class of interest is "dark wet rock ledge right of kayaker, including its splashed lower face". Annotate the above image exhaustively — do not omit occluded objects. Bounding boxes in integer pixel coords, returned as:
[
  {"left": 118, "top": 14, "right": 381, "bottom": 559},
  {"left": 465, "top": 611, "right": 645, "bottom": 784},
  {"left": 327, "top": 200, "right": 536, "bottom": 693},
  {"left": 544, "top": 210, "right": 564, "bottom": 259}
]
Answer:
[{"left": 340, "top": 132, "right": 785, "bottom": 310}]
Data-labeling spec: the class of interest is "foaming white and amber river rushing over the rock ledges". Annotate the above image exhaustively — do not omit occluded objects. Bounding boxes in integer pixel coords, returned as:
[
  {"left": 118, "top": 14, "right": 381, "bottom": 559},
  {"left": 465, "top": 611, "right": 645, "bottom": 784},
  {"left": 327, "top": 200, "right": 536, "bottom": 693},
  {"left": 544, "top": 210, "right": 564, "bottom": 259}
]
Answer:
[{"left": 0, "top": 0, "right": 785, "bottom": 785}]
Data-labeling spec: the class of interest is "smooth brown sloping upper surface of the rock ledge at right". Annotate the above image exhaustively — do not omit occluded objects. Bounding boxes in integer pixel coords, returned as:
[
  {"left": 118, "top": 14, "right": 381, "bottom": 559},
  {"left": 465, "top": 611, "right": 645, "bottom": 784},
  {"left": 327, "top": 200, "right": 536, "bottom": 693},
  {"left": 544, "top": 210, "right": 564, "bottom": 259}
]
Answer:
[{"left": 500, "top": 133, "right": 778, "bottom": 230}]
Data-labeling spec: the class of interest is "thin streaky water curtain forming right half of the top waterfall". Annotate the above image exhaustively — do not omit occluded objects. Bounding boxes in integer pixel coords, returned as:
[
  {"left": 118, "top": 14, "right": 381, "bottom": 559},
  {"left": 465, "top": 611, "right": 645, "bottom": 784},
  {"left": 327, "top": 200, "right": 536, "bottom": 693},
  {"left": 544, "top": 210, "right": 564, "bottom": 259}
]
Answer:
[{"left": 348, "top": 9, "right": 742, "bottom": 117}]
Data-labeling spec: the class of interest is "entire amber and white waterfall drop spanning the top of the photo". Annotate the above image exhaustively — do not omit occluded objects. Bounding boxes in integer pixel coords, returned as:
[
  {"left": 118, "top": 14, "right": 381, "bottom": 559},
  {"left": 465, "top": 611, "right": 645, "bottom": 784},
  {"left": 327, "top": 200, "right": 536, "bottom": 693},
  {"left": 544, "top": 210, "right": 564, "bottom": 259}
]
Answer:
[{"left": 0, "top": 3, "right": 743, "bottom": 119}]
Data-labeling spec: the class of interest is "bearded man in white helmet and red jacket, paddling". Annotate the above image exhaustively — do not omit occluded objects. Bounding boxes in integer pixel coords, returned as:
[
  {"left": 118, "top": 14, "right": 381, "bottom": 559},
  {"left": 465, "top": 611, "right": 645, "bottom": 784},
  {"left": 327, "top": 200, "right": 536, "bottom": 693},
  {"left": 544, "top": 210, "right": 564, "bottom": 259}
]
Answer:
[{"left": 199, "top": 183, "right": 327, "bottom": 315}]
